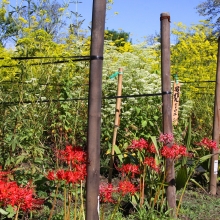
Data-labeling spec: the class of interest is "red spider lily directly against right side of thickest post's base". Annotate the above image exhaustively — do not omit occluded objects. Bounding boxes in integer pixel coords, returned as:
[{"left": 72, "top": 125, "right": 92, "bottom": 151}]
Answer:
[{"left": 99, "top": 184, "right": 117, "bottom": 203}]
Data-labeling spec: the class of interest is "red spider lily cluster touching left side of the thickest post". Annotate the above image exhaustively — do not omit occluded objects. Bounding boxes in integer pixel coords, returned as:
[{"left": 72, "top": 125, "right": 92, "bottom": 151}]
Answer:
[{"left": 47, "top": 145, "right": 87, "bottom": 184}]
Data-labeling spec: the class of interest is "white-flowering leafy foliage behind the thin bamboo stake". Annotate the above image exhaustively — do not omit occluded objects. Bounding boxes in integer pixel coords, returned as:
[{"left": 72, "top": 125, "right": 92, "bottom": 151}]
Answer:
[{"left": 101, "top": 41, "right": 161, "bottom": 157}]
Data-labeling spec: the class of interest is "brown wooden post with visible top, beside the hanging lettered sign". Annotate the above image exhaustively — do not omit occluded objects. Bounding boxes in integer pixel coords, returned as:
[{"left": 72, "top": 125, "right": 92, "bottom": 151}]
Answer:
[{"left": 160, "top": 13, "right": 176, "bottom": 216}]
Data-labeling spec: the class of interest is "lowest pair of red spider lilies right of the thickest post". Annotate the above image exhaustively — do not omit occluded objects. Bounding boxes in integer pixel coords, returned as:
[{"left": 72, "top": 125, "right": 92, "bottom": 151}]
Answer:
[{"left": 99, "top": 181, "right": 137, "bottom": 203}]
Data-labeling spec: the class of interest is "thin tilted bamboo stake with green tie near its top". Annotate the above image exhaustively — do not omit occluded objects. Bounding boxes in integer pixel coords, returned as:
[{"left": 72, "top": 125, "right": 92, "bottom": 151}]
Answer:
[{"left": 108, "top": 68, "right": 123, "bottom": 183}]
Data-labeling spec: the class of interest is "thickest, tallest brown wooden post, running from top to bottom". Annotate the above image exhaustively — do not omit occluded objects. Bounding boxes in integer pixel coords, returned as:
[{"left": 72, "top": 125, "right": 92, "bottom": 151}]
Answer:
[{"left": 86, "top": 0, "right": 106, "bottom": 220}]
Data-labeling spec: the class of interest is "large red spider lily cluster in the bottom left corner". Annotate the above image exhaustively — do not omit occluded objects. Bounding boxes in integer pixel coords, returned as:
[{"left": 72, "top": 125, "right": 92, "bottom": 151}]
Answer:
[{"left": 0, "top": 174, "right": 44, "bottom": 211}]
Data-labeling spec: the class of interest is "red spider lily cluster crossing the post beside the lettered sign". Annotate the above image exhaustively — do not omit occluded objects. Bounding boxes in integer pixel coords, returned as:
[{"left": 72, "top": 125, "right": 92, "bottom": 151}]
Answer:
[{"left": 161, "top": 144, "right": 188, "bottom": 159}]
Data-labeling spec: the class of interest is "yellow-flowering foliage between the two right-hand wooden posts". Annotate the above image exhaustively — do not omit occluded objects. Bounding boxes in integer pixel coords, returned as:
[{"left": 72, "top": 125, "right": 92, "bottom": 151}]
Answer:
[{"left": 171, "top": 22, "right": 218, "bottom": 142}]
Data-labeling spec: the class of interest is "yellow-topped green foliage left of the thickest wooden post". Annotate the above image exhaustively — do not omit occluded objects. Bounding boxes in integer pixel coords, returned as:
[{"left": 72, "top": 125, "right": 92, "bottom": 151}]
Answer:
[{"left": 0, "top": 29, "right": 88, "bottom": 174}]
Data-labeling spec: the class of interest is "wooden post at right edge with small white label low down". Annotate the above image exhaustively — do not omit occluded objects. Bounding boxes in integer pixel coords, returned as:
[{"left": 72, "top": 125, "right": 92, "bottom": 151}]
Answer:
[{"left": 209, "top": 37, "right": 220, "bottom": 195}]
